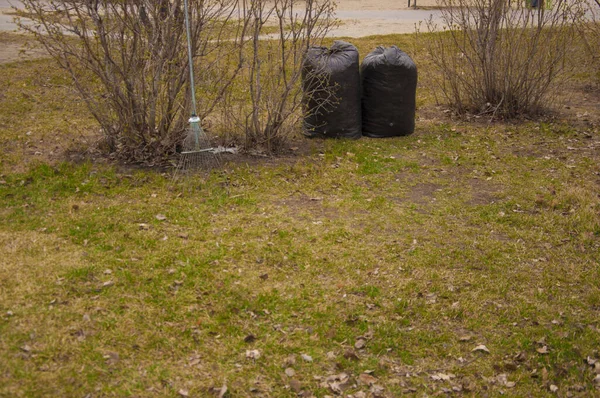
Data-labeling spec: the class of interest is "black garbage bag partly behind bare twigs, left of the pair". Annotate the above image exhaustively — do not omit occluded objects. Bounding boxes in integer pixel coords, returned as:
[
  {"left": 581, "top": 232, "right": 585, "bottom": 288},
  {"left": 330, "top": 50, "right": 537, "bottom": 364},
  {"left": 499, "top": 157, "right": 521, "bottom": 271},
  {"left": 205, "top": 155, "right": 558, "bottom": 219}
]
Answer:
[{"left": 302, "top": 41, "right": 362, "bottom": 138}]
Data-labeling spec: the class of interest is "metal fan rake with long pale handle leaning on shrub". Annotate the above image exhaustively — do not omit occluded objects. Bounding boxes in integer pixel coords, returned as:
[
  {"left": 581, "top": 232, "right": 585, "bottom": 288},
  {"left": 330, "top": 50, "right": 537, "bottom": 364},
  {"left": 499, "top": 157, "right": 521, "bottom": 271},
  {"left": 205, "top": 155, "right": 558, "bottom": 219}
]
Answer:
[{"left": 176, "top": 0, "right": 220, "bottom": 175}]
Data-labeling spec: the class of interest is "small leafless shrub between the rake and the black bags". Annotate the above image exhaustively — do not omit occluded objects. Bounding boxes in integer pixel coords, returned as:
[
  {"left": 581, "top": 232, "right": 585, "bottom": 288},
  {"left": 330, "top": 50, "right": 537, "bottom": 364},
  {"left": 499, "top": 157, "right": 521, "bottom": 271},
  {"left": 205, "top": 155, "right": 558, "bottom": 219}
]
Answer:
[{"left": 223, "top": 0, "right": 335, "bottom": 152}]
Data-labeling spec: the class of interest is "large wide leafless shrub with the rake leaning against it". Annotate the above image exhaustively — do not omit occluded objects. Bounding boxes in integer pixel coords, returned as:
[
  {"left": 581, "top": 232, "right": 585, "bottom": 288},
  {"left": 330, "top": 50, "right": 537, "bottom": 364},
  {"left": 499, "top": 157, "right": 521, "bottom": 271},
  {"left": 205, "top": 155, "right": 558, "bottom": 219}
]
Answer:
[{"left": 21, "top": 0, "right": 246, "bottom": 163}]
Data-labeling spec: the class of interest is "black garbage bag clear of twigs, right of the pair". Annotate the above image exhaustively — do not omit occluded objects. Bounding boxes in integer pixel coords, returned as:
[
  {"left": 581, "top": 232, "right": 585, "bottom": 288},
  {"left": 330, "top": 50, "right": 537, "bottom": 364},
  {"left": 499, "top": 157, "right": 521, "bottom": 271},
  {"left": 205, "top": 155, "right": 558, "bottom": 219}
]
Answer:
[{"left": 360, "top": 46, "right": 417, "bottom": 138}]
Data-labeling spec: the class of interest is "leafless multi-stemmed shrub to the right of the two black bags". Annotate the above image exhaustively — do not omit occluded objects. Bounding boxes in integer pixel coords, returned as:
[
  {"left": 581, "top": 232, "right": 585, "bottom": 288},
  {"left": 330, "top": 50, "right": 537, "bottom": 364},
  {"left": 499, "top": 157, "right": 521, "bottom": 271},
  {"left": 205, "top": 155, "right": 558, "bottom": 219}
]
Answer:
[{"left": 427, "top": 0, "right": 581, "bottom": 117}]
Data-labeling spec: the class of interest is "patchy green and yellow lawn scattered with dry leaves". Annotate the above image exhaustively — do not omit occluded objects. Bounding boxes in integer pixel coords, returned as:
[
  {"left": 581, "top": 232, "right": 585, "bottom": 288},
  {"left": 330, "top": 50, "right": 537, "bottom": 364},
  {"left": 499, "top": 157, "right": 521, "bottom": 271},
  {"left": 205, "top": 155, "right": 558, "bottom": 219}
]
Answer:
[{"left": 0, "top": 31, "right": 600, "bottom": 398}]
